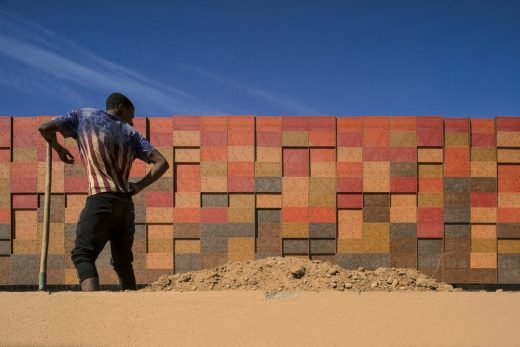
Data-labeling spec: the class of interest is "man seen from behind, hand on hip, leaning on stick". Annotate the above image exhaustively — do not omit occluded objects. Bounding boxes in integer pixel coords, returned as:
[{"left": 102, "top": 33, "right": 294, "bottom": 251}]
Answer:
[{"left": 38, "top": 93, "right": 168, "bottom": 291}]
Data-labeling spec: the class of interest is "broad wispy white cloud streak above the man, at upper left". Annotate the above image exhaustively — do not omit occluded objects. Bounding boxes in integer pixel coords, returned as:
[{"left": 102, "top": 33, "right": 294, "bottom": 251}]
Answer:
[{"left": 0, "top": 11, "right": 215, "bottom": 113}]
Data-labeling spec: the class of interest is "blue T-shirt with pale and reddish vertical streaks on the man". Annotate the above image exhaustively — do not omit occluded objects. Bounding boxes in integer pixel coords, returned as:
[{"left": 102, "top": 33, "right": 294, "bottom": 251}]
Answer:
[{"left": 54, "top": 108, "right": 154, "bottom": 195}]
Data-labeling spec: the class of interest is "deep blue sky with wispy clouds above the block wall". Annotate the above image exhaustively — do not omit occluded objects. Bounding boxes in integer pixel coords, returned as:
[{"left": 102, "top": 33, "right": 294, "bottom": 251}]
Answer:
[{"left": 0, "top": 0, "right": 520, "bottom": 117}]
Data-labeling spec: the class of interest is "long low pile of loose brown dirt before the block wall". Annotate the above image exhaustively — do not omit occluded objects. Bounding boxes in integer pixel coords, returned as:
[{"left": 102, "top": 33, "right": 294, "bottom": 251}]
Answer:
[{"left": 141, "top": 257, "right": 461, "bottom": 292}]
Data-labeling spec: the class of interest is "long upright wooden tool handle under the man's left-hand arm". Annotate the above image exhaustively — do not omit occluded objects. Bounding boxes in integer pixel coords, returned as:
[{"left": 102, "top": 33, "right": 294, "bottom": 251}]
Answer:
[{"left": 38, "top": 143, "right": 52, "bottom": 290}]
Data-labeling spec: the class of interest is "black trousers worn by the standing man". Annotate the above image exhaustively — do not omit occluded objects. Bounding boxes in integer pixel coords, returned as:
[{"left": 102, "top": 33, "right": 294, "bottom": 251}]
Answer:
[{"left": 71, "top": 192, "right": 136, "bottom": 290}]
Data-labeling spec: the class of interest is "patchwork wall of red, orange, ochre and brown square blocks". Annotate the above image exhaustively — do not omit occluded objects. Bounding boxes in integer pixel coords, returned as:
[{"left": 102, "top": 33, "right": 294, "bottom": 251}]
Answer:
[{"left": 0, "top": 116, "right": 520, "bottom": 285}]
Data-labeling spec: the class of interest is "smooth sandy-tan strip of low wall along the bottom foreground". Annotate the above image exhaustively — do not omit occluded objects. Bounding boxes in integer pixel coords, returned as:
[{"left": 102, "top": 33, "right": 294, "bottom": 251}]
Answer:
[{"left": 0, "top": 291, "right": 520, "bottom": 346}]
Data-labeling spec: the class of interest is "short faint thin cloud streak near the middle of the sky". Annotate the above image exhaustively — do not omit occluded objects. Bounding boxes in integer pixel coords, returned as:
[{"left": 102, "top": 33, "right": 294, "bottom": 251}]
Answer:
[{"left": 179, "top": 64, "right": 319, "bottom": 114}]
